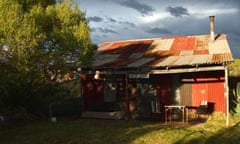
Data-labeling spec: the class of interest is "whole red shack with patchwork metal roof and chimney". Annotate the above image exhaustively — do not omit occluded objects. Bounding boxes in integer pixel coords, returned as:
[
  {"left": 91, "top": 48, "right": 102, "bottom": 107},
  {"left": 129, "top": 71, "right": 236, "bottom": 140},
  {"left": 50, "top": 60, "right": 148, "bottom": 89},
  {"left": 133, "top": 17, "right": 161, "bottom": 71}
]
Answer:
[{"left": 79, "top": 16, "right": 233, "bottom": 121}]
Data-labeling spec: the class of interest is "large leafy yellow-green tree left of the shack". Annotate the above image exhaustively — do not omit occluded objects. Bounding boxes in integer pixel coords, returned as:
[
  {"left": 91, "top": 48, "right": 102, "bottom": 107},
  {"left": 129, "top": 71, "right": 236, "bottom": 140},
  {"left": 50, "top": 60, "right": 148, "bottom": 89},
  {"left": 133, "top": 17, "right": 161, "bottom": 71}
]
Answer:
[{"left": 0, "top": 0, "right": 94, "bottom": 117}]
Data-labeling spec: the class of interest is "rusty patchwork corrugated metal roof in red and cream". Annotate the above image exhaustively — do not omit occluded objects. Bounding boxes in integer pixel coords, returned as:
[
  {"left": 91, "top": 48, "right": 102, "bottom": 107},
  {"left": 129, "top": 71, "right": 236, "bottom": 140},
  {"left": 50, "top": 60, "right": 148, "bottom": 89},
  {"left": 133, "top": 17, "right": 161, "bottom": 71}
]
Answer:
[{"left": 94, "top": 34, "right": 233, "bottom": 68}]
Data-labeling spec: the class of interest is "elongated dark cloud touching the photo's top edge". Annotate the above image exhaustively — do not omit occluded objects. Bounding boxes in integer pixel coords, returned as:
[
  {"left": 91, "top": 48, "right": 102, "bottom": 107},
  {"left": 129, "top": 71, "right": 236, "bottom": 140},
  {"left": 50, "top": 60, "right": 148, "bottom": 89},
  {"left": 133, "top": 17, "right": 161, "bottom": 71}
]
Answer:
[{"left": 116, "top": 0, "right": 155, "bottom": 15}]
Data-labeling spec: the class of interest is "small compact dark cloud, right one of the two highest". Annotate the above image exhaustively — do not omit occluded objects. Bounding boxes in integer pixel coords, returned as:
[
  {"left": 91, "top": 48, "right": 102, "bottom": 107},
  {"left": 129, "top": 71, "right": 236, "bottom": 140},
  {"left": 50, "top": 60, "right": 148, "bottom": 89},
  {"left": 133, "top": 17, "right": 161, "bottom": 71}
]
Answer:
[{"left": 166, "top": 6, "right": 189, "bottom": 17}]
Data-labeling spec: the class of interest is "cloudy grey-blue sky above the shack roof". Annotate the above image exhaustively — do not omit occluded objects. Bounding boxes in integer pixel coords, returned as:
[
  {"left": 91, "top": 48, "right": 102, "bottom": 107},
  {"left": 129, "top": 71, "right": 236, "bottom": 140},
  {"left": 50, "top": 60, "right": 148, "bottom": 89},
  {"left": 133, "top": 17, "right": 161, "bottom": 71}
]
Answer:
[{"left": 76, "top": 0, "right": 240, "bottom": 58}]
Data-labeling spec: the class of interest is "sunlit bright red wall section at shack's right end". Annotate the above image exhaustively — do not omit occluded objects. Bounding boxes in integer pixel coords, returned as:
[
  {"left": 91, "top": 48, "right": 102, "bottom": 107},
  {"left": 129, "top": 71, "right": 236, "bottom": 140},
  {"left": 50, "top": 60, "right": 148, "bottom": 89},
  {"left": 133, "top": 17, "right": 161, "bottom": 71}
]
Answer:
[{"left": 192, "top": 72, "right": 226, "bottom": 113}]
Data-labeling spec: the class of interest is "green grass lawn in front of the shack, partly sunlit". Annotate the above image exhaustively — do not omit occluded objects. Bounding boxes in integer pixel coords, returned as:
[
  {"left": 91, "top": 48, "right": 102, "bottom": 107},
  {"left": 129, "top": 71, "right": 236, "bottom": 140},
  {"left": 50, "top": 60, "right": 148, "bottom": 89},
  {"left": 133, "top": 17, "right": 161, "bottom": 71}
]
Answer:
[{"left": 0, "top": 117, "right": 240, "bottom": 144}]
